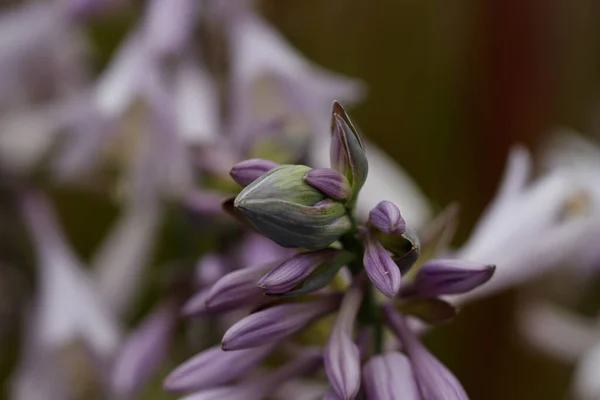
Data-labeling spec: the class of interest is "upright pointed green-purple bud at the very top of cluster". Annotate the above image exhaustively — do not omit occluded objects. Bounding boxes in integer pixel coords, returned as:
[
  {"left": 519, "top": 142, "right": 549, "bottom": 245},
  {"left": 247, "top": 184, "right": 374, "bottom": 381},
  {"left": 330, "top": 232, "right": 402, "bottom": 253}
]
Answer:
[{"left": 330, "top": 101, "right": 369, "bottom": 198}]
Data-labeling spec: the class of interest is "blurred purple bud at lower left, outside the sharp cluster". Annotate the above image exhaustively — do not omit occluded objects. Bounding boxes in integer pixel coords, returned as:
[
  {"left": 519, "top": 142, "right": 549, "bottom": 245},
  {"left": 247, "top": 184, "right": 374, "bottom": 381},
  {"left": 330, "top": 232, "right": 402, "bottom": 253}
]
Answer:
[{"left": 111, "top": 303, "right": 177, "bottom": 397}]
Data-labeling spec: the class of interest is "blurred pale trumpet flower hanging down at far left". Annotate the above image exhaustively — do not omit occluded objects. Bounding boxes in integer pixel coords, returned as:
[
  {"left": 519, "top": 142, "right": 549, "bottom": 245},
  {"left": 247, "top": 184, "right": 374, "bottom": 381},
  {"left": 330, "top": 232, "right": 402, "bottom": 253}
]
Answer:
[{"left": 21, "top": 192, "right": 119, "bottom": 357}]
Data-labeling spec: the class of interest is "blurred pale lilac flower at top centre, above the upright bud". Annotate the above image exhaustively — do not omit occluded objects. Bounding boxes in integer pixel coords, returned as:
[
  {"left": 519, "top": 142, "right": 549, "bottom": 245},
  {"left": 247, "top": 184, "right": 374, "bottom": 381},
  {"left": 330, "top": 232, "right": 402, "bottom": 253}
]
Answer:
[{"left": 227, "top": 7, "right": 361, "bottom": 141}]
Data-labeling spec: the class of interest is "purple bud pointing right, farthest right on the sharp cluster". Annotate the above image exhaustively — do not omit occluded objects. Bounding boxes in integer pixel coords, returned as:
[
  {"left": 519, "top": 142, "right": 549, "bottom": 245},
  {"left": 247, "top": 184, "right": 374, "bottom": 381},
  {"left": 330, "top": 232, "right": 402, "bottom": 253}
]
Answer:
[{"left": 402, "top": 258, "right": 496, "bottom": 297}]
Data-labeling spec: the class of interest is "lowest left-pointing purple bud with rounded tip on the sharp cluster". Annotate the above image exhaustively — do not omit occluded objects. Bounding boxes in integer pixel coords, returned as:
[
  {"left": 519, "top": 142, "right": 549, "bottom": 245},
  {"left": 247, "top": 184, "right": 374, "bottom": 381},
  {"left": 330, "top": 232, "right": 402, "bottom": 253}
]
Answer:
[{"left": 163, "top": 345, "right": 274, "bottom": 392}]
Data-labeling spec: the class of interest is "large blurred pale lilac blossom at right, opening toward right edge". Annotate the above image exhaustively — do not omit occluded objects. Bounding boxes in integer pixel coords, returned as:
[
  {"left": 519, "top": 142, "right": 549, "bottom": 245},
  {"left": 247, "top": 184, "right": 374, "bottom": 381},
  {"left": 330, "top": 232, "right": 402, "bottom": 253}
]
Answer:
[{"left": 458, "top": 148, "right": 600, "bottom": 300}]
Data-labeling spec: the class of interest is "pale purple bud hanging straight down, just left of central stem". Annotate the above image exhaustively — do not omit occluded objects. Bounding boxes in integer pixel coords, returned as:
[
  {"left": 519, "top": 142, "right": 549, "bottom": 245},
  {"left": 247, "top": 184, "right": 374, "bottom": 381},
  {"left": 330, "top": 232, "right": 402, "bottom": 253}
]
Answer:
[{"left": 324, "top": 286, "right": 362, "bottom": 400}]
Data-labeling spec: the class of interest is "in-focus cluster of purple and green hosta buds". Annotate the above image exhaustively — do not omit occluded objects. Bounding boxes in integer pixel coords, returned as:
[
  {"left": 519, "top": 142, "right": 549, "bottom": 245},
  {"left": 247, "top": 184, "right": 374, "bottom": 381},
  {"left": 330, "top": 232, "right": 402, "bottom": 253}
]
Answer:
[{"left": 165, "top": 103, "right": 494, "bottom": 400}]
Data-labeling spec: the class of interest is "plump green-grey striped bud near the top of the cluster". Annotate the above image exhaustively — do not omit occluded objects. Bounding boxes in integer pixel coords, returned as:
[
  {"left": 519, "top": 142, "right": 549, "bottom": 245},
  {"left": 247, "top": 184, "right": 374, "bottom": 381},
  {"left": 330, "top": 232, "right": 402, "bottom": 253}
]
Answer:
[{"left": 234, "top": 165, "right": 351, "bottom": 250}]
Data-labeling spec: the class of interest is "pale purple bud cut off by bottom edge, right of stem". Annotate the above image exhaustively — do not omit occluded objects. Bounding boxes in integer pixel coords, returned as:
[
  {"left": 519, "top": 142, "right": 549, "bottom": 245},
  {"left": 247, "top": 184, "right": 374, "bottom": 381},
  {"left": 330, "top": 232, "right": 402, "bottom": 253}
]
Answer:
[{"left": 363, "top": 352, "right": 421, "bottom": 400}]
